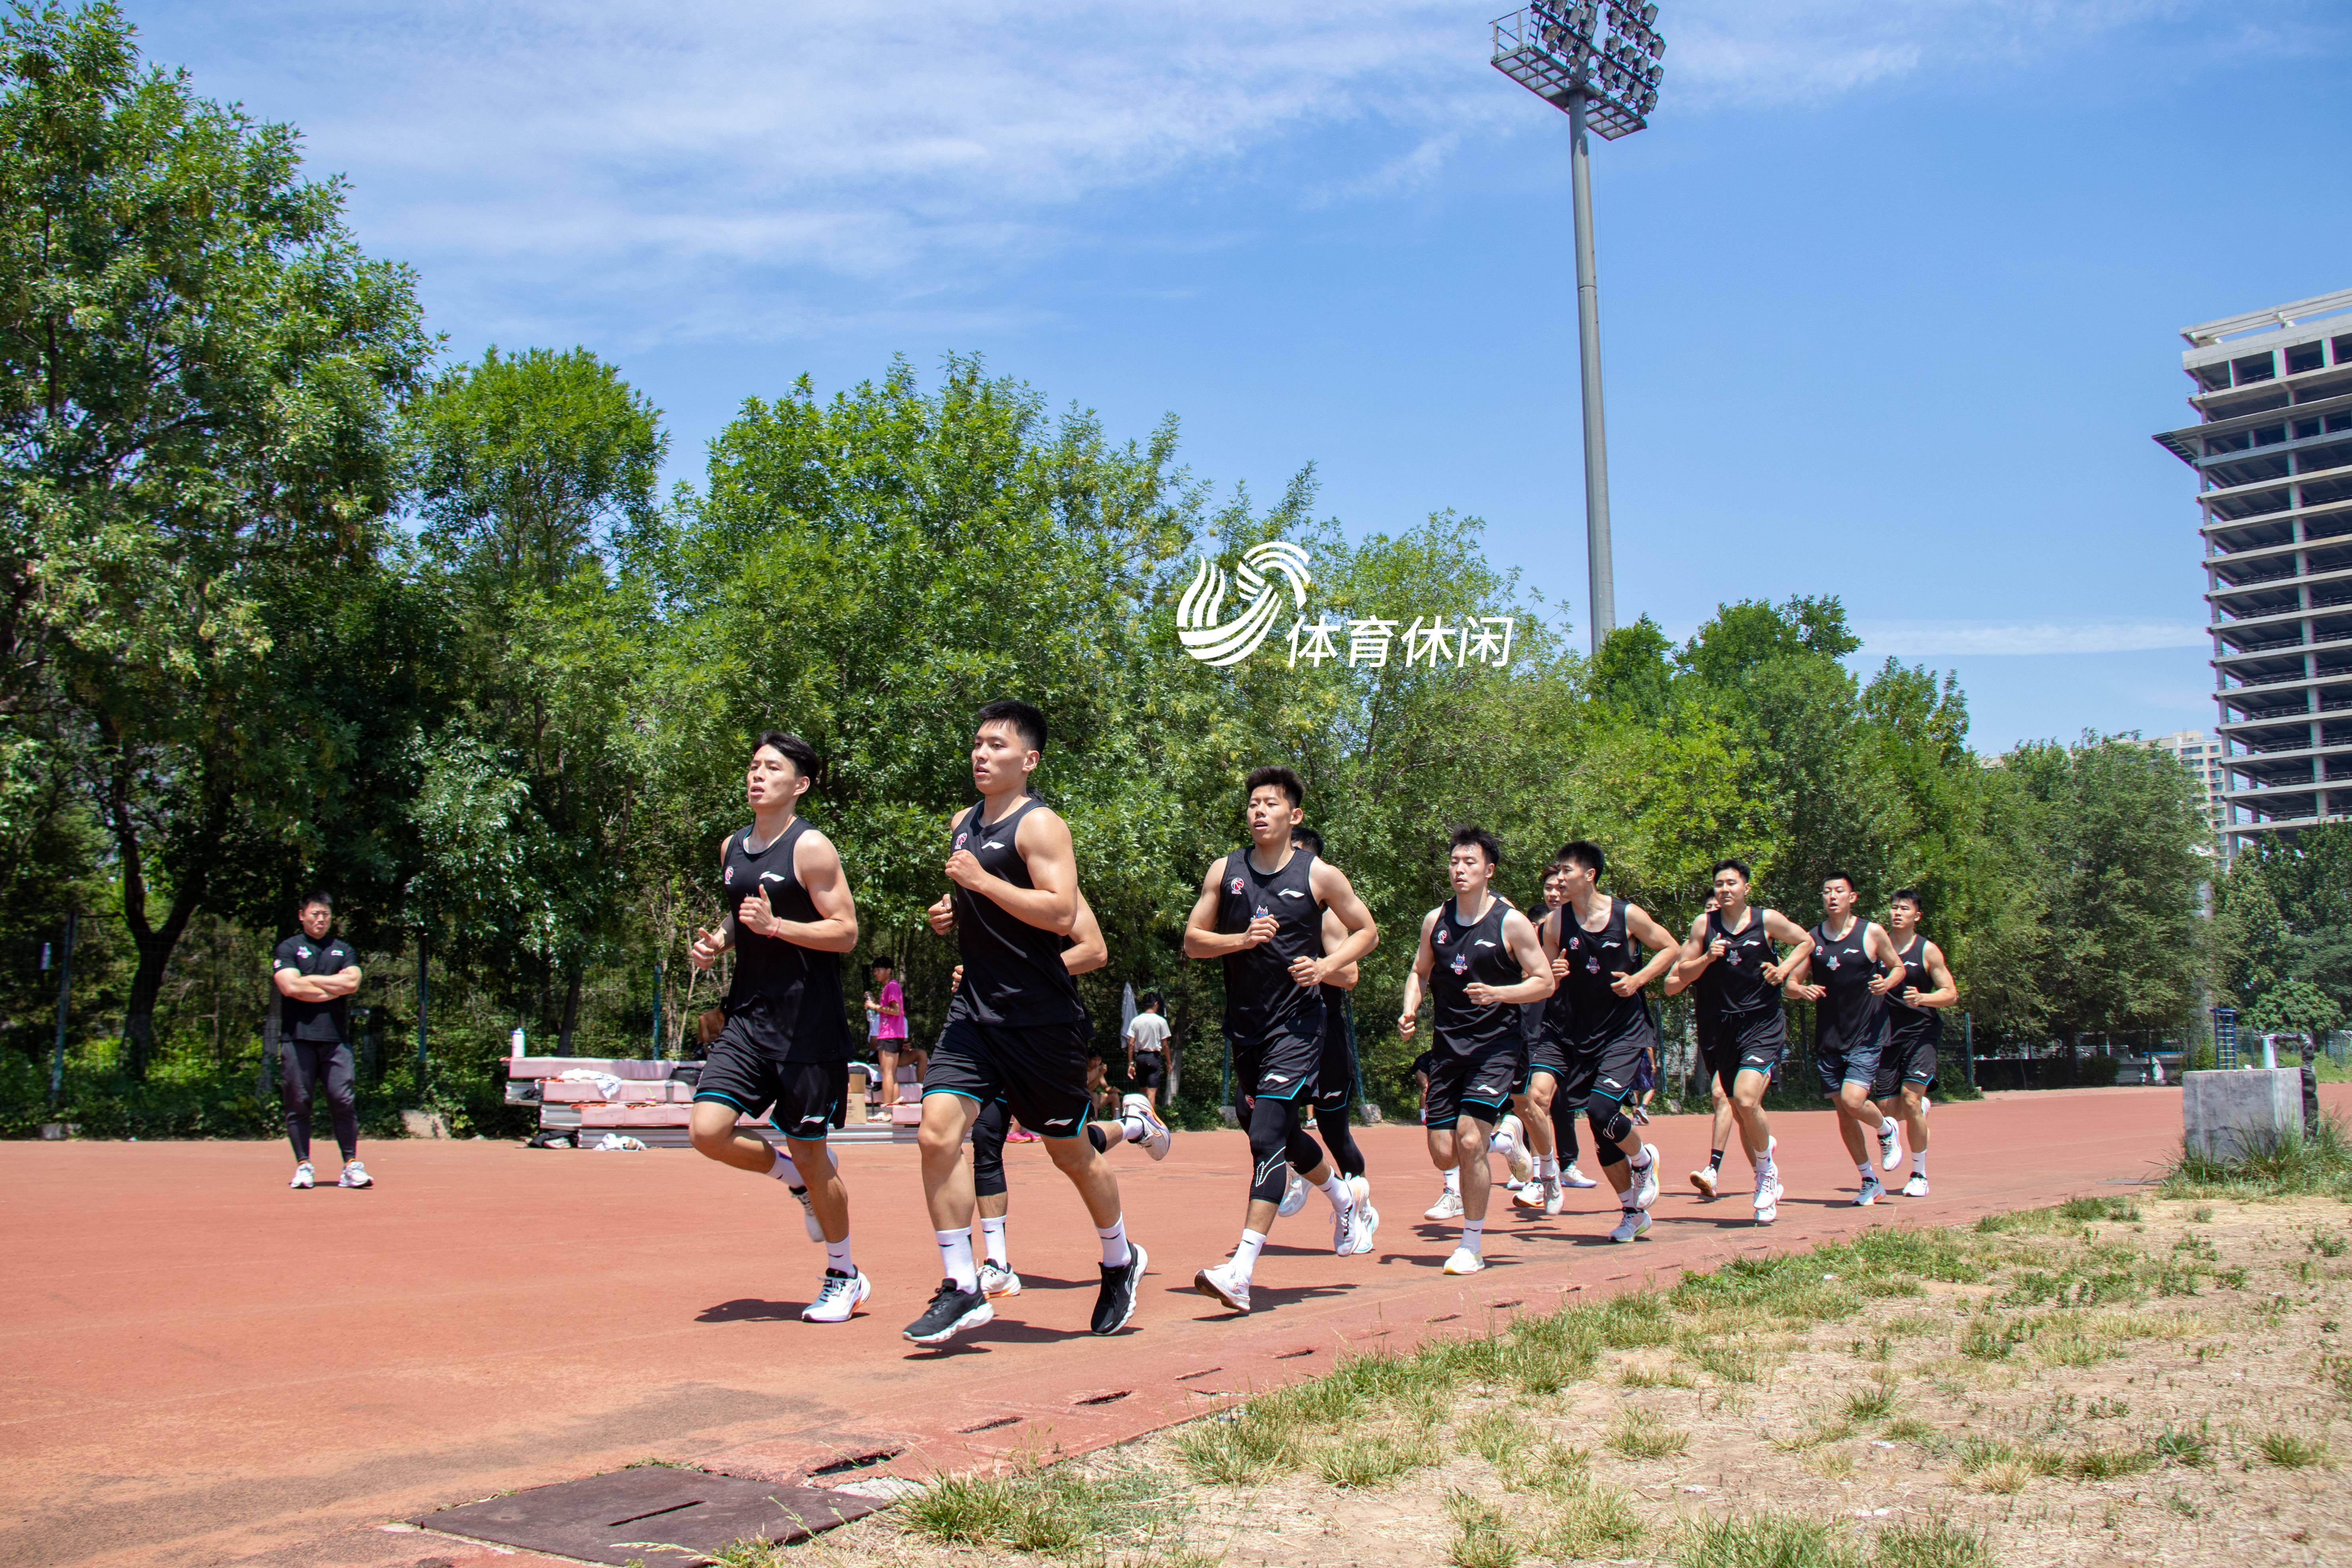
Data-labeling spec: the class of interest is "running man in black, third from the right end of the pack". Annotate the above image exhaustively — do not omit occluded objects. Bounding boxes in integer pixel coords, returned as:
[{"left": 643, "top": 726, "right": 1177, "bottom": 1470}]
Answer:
[{"left": 1675, "top": 860, "right": 1813, "bottom": 1225}]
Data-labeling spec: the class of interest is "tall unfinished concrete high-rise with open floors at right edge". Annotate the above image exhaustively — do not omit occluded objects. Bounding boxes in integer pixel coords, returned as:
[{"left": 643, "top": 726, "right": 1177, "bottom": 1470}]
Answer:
[{"left": 2157, "top": 289, "right": 2352, "bottom": 853}]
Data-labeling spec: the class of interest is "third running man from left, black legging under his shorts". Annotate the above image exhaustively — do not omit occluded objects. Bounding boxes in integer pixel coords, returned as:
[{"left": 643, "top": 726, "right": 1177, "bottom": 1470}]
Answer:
[{"left": 1183, "top": 766, "right": 1381, "bottom": 1312}]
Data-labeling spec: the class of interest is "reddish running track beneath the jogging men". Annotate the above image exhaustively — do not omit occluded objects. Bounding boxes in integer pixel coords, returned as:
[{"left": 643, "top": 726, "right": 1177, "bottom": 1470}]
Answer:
[{"left": 0, "top": 1086, "right": 2314, "bottom": 1568}]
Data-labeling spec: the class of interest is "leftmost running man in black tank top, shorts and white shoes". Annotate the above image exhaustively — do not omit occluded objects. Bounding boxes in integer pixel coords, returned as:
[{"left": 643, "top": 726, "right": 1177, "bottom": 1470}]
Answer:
[{"left": 687, "top": 729, "right": 872, "bottom": 1324}]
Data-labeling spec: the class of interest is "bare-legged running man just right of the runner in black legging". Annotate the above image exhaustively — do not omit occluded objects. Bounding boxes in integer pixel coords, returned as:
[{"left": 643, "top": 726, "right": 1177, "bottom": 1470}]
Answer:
[{"left": 1397, "top": 828, "right": 1552, "bottom": 1274}]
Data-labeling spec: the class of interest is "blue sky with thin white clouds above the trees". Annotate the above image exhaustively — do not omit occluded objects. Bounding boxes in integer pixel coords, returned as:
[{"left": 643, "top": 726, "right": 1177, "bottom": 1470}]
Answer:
[{"left": 130, "top": 0, "right": 2352, "bottom": 750}]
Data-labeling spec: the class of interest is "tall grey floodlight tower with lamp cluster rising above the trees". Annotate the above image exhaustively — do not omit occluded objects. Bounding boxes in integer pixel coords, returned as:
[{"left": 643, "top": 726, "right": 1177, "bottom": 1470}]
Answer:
[{"left": 1493, "top": 0, "right": 1665, "bottom": 653}]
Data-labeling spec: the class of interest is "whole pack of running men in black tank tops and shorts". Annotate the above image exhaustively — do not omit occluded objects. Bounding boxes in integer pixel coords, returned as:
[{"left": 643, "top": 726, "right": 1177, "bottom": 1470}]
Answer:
[{"left": 689, "top": 700, "right": 1957, "bottom": 1345}]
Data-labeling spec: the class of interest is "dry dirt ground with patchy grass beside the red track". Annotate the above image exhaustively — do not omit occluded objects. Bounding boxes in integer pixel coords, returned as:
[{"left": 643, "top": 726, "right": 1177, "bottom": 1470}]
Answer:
[{"left": 757, "top": 1194, "right": 2352, "bottom": 1568}]
